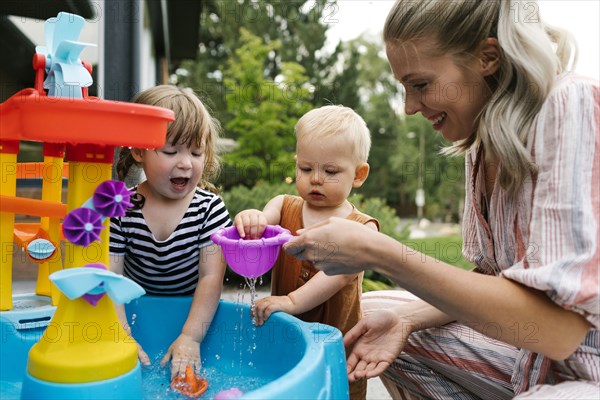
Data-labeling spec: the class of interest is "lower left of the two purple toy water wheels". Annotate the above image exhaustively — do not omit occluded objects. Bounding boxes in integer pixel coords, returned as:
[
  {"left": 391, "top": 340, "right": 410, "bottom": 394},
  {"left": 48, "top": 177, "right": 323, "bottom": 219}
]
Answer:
[{"left": 63, "top": 207, "right": 104, "bottom": 247}]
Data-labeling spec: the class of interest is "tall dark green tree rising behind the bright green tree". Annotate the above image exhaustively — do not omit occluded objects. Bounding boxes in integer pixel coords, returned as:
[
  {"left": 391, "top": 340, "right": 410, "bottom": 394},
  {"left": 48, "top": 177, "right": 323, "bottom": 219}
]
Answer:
[{"left": 173, "top": 0, "right": 339, "bottom": 119}]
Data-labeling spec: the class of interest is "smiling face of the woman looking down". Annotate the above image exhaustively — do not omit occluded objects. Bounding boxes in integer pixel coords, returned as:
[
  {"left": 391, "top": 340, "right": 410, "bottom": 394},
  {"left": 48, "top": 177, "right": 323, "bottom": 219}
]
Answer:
[{"left": 386, "top": 39, "right": 490, "bottom": 142}]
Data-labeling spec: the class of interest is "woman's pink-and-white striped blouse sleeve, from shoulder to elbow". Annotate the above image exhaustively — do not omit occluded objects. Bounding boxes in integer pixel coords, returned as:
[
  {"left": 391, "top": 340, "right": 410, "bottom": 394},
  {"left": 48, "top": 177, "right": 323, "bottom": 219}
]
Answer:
[{"left": 503, "top": 76, "right": 600, "bottom": 328}]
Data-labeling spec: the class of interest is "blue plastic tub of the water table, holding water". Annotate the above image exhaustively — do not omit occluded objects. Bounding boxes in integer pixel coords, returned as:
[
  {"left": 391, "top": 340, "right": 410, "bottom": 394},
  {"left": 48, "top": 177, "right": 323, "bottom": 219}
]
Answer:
[{"left": 0, "top": 296, "right": 348, "bottom": 400}]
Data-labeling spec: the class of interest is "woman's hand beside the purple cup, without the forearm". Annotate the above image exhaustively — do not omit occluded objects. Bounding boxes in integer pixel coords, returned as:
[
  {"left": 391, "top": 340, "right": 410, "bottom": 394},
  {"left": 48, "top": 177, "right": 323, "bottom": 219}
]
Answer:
[{"left": 283, "top": 218, "right": 379, "bottom": 275}]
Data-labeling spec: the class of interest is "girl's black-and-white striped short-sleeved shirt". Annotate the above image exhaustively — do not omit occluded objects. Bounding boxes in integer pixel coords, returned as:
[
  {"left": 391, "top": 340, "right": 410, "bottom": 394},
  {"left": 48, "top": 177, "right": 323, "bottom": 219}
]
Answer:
[{"left": 110, "top": 188, "right": 231, "bottom": 295}]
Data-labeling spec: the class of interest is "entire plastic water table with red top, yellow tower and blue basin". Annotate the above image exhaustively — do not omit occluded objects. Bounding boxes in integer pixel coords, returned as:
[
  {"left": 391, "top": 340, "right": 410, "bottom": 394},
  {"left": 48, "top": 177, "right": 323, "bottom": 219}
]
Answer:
[{"left": 0, "top": 13, "right": 348, "bottom": 400}]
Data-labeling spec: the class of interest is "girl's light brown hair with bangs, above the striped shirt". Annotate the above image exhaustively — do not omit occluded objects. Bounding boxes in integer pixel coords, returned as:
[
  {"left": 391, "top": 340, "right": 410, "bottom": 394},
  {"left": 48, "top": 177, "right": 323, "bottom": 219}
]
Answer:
[{"left": 116, "top": 85, "right": 221, "bottom": 191}]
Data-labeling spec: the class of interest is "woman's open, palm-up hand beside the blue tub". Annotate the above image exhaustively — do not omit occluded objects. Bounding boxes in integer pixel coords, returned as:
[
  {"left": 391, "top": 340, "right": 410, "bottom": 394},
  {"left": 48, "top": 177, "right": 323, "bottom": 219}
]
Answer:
[{"left": 344, "top": 309, "right": 412, "bottom": 382}]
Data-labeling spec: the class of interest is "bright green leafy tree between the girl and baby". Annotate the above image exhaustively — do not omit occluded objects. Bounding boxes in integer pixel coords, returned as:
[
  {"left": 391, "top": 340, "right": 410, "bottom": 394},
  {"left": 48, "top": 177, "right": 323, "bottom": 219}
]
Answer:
[{"left": 223, "top": 28, "right": 310, "bottom": 187}]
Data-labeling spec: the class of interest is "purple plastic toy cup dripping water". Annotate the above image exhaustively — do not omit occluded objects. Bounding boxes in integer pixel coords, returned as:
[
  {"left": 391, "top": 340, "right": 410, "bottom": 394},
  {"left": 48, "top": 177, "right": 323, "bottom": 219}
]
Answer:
[{"left": 210, "top": 225, "right": 292, "bottom": 278}]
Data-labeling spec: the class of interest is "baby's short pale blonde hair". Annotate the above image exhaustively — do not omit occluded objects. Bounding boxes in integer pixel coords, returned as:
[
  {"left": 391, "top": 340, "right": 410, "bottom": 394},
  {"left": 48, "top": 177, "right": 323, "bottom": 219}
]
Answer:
[{"left": 295, "top": 105, "right": 371, "bottom": 165}]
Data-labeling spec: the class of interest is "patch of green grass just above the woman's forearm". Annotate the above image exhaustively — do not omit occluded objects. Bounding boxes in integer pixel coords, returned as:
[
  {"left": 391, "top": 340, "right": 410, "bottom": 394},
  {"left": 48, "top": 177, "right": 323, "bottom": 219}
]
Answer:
[{"left": 402, "top": 235, "right": 474, "bottom": 270}]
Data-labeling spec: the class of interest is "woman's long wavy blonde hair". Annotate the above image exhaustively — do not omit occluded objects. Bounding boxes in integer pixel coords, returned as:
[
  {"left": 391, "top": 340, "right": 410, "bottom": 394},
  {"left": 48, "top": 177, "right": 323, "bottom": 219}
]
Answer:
[{"left": 383, "top": 0, "right": 577, "bottom": 194}]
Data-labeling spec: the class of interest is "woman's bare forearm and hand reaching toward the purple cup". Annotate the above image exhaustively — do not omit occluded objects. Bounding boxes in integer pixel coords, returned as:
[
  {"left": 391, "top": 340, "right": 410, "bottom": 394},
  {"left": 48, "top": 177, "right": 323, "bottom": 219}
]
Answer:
[{"left": 284, "top": 218, "right": 590, "bottom": 360}]
